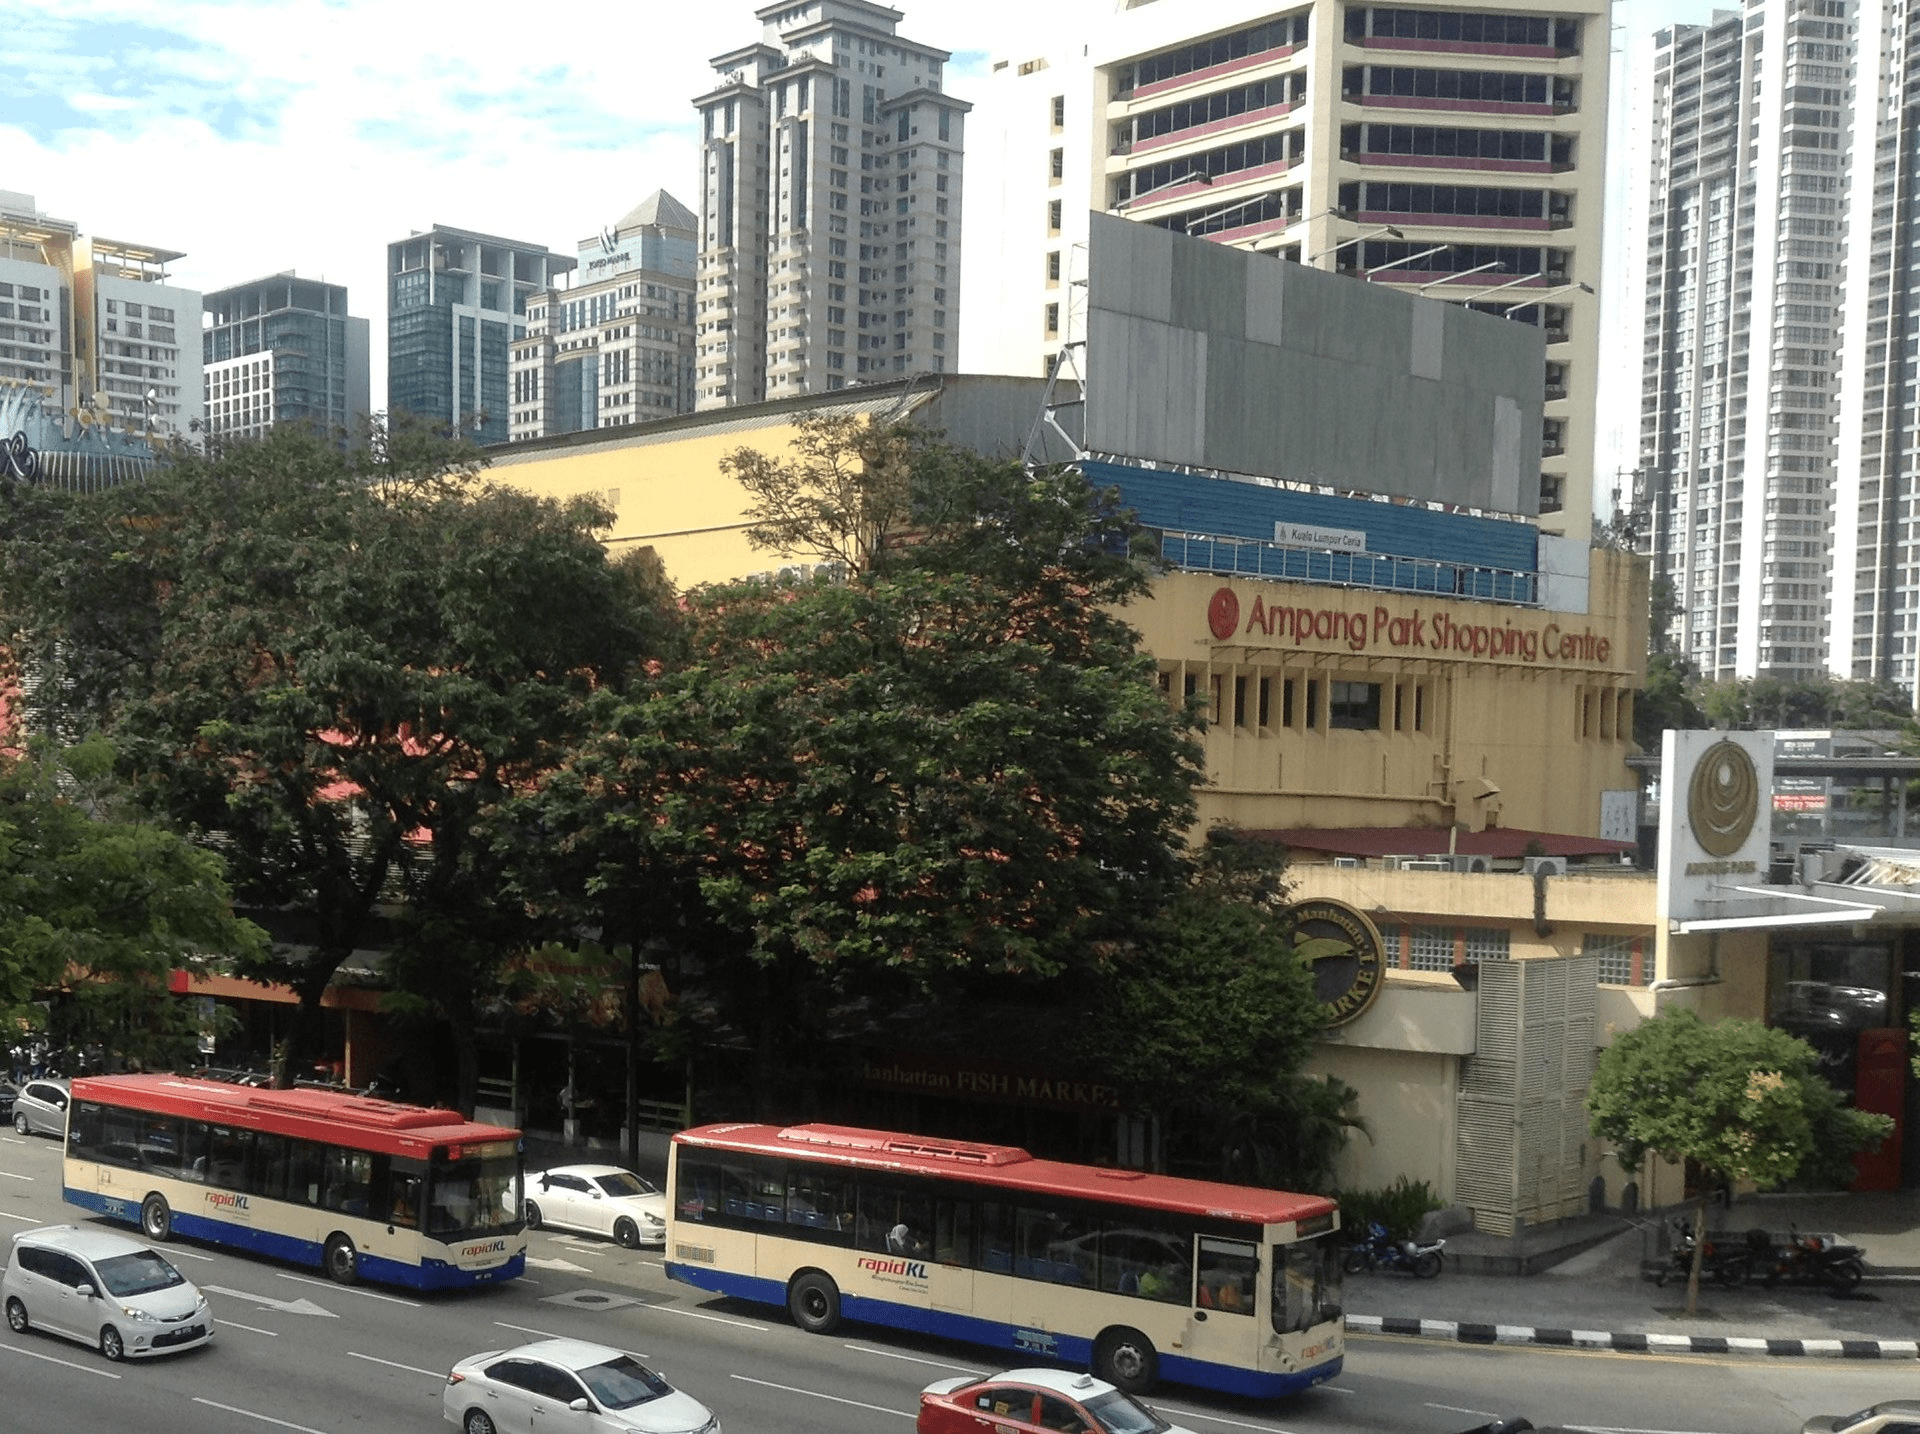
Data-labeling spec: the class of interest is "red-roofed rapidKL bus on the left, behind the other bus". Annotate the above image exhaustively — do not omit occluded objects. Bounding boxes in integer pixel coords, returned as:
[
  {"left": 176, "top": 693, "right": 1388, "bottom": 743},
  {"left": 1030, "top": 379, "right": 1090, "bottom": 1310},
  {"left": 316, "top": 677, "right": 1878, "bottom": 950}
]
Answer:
[{"left": 63, "top": 1075, "right": 526, "bottom": 1290}]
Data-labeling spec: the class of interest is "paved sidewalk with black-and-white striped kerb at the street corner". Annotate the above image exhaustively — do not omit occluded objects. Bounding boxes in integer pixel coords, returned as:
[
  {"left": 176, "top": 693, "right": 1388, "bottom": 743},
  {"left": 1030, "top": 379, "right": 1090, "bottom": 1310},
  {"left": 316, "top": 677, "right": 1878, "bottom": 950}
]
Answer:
[{"left": 1346, "top": 1194, "right": 1920, "bottom": 1361}]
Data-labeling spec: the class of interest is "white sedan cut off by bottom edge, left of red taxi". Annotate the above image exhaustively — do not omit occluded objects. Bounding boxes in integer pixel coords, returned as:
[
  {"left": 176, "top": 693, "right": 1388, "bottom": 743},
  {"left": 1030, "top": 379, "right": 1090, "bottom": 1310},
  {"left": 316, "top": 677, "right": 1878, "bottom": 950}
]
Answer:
[{"left": 440, "top": 1340, "right": 720, "bottom": 1434}]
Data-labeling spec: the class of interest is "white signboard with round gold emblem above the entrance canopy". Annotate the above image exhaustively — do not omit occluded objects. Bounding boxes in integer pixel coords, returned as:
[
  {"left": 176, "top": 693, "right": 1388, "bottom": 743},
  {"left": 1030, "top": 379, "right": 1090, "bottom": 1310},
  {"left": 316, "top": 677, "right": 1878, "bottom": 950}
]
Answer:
[{"left": 1659, "top": 731, "right": 1774, "bottom": 921}]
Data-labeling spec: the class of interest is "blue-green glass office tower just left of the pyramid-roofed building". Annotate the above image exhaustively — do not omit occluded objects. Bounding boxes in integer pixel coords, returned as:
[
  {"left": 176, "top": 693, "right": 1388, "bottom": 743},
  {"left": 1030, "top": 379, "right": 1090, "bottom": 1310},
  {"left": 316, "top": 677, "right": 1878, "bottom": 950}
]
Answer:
[{"left": 386, "top": 225, "right": 574, "bottom": 443}]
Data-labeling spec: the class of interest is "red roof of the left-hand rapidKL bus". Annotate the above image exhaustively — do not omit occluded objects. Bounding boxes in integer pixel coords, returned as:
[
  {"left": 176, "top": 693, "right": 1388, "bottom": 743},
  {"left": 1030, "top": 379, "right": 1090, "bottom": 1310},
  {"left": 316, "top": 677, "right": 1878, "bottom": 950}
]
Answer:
[{"left": 73, "top": 1075, "right": 520, "bottom": 1158}]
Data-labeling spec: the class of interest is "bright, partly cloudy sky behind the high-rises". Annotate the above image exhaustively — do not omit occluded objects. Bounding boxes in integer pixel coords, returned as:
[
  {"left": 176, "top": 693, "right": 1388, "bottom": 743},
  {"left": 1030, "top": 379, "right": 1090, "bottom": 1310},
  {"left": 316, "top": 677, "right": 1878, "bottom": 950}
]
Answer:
[{"left": 0, "top": 0, "right": 1713, "bottom": 490}]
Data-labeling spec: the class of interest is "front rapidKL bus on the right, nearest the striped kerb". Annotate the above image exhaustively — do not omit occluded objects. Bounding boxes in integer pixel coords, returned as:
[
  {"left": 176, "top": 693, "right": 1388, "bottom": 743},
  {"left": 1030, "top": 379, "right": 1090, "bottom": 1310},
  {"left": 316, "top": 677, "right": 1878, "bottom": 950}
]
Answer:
[{"left": 666, "top": 1125, "right": 1344, "bottom": 1396}]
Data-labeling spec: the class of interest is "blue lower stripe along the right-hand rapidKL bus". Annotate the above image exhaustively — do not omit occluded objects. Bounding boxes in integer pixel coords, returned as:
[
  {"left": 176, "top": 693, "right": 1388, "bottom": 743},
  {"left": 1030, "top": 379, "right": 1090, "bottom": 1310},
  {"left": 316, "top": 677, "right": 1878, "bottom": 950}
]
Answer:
[{"left": 666, "top": 1261, "right": 1344, "bottom": 1399}]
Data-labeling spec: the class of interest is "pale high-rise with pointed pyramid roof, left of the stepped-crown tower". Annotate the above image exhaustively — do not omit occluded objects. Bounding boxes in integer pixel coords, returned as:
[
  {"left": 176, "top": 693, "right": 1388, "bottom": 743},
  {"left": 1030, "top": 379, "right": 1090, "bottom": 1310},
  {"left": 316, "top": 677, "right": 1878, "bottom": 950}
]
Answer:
[{"left": 509, "top": 190, "right": 699, "bottom": 443}]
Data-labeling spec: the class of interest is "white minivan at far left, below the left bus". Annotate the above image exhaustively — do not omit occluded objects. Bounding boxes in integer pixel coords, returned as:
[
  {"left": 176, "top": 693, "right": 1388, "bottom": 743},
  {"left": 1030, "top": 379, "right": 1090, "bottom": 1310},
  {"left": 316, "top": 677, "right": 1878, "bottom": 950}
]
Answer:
[{"left": 0, "top": 1225, "right": 213, "bottom": 1361}]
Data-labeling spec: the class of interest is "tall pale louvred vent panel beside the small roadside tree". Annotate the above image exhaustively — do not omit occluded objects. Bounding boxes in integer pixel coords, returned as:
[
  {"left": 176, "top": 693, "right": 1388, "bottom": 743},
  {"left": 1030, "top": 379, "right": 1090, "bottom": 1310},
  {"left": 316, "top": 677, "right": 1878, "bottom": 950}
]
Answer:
[{"left": 1453, "top": 956, "right": 1599, "bottom": 1234}]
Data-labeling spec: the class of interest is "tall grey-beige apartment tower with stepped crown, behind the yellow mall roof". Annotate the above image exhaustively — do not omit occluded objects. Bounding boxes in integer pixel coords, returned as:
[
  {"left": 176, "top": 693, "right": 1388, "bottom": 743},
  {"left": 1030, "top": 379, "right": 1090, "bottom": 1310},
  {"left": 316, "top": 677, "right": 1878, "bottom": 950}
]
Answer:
[{"left": 695, "top": 0, "right": 972, "bottom": 409}]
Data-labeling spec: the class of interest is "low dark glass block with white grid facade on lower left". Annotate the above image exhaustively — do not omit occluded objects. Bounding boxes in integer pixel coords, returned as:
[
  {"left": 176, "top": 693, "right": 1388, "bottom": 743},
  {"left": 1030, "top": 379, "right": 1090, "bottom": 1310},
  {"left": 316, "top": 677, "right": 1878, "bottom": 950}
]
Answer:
[{"left": 202, "top": 273, "right": 371, "bottom": 445}]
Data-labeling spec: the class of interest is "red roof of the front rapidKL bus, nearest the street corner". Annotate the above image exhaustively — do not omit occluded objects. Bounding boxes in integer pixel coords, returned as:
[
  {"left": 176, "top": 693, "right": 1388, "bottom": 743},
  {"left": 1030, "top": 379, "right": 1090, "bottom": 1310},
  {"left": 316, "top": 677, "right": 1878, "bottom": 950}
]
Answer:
[{"left": 674, "top": 1125, "right": 1338, "bottom": 1225}]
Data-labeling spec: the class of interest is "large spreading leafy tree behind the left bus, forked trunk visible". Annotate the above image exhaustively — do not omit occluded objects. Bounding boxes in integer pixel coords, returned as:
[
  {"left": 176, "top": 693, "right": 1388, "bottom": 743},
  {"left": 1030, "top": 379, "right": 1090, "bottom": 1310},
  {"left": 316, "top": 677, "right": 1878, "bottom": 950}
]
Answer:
[{"left": 0, "top": 428, "right": 660, "bottom": 1100}]
